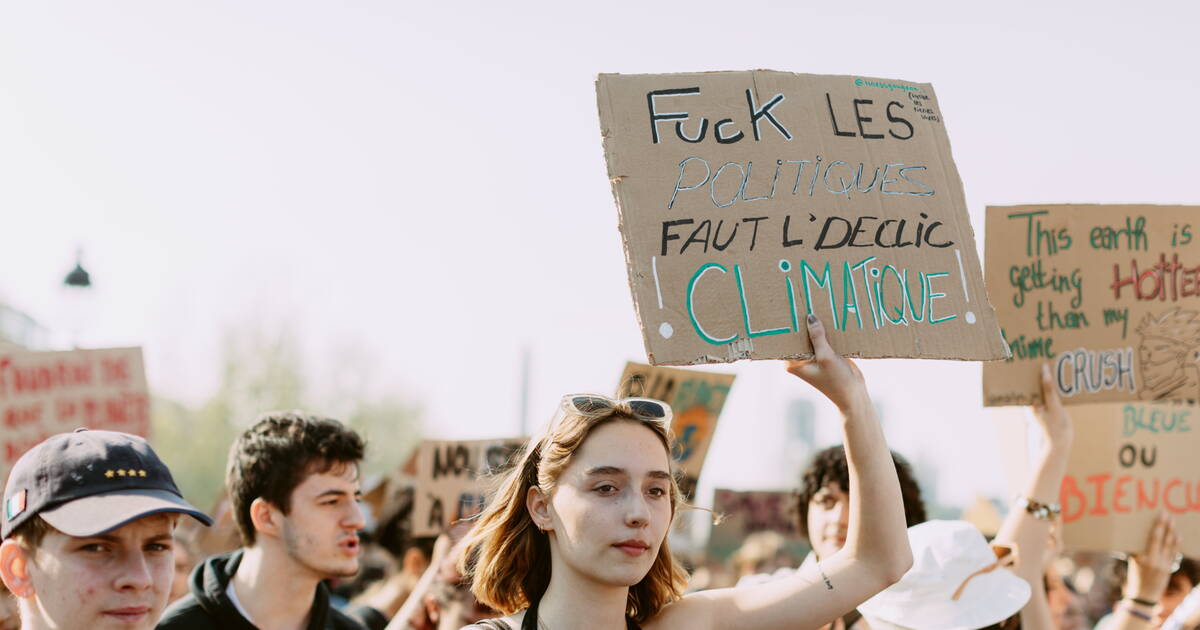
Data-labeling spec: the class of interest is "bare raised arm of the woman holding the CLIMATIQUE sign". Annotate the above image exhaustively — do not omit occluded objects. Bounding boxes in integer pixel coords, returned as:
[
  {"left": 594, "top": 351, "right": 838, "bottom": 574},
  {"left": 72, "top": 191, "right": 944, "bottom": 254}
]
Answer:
[{"left": 647, "top": 316, "right": 912, "bottom": 630}]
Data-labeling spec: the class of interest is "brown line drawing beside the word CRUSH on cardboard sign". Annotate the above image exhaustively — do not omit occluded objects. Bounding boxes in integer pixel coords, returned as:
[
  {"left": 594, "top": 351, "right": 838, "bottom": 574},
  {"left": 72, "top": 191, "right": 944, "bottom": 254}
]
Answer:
[{"left": 1136, "top": 308, "right": 1200, "bottom": 401}]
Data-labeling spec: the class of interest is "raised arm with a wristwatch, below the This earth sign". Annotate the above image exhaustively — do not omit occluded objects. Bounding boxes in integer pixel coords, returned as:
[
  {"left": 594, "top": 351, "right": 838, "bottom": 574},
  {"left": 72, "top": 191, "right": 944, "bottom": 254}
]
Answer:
[{"left": 995, "top": 364, "right": 1073, "bottom": 630}]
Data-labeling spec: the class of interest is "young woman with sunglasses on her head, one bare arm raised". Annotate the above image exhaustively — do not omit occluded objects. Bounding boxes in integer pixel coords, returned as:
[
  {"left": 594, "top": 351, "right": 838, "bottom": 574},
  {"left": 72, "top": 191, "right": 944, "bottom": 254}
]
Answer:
[{"left": 462, "top": 317, "right": 912, "bottom": 630}]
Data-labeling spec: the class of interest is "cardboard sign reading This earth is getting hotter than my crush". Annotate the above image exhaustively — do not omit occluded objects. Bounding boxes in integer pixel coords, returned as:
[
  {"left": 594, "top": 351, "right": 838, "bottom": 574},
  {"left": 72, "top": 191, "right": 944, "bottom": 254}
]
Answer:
[{"left": 983, "top": 205, "right": 1200, "bottom": 406}]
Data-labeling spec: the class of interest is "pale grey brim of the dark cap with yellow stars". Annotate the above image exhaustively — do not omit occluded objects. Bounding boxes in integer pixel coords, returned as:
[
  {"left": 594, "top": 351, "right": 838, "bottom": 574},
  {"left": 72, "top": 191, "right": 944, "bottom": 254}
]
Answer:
[{"left": 40, "top": 490, "right": 212, "bottom": 538}]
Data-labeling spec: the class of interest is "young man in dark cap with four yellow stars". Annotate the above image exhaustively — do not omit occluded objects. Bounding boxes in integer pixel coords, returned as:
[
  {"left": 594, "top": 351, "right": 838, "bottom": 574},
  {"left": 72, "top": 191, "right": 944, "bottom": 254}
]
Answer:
[{"left": 0, "top": 430, "right": 211, "bottom": 630}]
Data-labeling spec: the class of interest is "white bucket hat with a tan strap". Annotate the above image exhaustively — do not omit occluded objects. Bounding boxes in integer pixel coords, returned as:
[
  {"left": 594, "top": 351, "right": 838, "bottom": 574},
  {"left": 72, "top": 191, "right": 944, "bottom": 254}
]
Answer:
[{"left": 858, "top": 521, "right": 1030, "bottom": 630}]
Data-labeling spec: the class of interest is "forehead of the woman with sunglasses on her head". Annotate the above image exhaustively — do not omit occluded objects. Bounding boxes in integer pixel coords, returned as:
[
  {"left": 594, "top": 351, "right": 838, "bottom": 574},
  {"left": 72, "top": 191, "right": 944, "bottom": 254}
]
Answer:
[{"left": 570, "top": 420, "right": 671, "bottom": 475}]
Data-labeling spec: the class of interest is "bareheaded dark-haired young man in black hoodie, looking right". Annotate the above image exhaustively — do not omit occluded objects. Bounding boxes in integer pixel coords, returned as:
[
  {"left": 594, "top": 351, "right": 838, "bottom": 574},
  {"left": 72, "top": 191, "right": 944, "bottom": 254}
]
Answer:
[{"left": 158, "top": 412, "right": 366, "bottom": 630}]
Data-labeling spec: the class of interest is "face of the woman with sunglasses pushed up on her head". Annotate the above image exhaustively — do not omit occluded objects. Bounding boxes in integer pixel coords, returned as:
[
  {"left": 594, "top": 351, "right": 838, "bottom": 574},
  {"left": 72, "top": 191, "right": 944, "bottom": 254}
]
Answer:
[{"left": 529, "top": 420, "right": 671, "bottom": 587}]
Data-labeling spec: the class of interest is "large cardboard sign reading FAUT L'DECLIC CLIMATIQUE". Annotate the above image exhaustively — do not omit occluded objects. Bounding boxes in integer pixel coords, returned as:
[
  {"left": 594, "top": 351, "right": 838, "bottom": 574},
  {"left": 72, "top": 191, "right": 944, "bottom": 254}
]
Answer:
[{"left": 596, "top": 71, "right": 1006, "bottom": 365}]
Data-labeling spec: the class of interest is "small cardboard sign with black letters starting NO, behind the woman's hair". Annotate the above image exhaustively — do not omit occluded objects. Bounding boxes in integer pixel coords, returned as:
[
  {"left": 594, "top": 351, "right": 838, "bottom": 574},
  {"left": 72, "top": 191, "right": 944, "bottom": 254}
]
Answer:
[{"left": 413, "top": 438, "right": 527, "bottom": 536}]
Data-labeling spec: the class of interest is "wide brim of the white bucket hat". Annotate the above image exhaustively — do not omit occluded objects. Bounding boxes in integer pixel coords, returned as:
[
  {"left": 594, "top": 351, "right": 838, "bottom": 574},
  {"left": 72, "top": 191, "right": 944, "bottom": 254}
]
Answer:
[{"left": 858, "top": 569, "right": 1030, "bottom": 630}]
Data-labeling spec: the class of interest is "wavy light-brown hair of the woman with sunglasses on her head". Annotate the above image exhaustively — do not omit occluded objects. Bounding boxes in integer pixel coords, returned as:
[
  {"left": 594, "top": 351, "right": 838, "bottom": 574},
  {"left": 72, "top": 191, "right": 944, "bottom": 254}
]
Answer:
[{"left": 458, "top": 396, "right": 688, "bottom": 624}]
